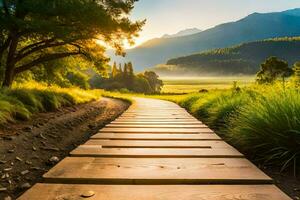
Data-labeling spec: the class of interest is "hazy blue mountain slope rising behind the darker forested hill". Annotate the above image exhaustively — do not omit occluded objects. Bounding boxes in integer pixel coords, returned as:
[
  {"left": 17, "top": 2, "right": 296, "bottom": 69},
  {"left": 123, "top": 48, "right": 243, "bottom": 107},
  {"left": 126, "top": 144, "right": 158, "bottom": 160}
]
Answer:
[{"left": 112, "top": 9, "right": 300, "bottom": 71}]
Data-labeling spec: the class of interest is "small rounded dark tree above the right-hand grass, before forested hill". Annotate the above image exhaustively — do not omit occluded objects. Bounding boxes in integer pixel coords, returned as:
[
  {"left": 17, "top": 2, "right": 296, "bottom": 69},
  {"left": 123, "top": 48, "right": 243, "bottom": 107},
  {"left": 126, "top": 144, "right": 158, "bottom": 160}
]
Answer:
[{"left": 256, "top": 57, "right": 293, "bottom": 84}]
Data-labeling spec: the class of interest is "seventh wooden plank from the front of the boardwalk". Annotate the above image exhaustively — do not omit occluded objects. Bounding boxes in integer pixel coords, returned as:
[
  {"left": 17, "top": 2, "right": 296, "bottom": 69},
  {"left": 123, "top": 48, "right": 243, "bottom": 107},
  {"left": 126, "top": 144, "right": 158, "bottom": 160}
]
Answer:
[{"left": 105, "top": 124, "right": 208, "bottom": 128}]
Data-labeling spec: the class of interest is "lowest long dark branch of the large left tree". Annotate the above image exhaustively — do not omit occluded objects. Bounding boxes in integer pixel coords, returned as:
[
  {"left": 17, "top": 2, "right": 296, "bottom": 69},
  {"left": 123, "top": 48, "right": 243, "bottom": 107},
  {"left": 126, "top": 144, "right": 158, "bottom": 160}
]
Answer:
[{"left": 15, "top": 51, "right": 81, "bottom": 74}]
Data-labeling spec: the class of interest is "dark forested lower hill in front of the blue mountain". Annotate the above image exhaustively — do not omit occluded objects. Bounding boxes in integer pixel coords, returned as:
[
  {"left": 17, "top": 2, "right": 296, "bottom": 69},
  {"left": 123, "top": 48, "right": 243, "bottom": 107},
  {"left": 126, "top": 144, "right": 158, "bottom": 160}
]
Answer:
[{"left": 154, "top": 37, "right": 300, "bottom": 75}]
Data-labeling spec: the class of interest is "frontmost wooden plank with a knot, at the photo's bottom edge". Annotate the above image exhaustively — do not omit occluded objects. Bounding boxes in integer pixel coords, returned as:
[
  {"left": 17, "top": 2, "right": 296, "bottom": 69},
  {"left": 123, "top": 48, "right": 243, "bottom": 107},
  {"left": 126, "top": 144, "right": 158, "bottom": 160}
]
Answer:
[{"left": 19, "top": 184, "right": 291, "bottom": 200}]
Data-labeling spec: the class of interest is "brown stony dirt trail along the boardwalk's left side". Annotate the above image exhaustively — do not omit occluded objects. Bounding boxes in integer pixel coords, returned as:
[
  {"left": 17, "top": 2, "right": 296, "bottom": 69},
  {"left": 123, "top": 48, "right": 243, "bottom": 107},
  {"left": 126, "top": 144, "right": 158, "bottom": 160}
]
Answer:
[{"left": 0, "top": 98, "right": 129, "bottom": 199}]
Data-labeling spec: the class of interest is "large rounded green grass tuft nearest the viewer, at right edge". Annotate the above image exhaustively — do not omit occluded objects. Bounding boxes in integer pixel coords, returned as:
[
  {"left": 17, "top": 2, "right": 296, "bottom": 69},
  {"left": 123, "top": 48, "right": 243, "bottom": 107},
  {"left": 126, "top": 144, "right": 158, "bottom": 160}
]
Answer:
[{"left": 227, "top": 90, "right": 300, "bottom": 169}]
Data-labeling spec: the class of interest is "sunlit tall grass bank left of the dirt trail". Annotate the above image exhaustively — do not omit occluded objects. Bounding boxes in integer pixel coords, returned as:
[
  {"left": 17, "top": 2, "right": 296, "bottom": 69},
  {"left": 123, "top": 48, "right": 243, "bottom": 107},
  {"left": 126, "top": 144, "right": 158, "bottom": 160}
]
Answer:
[{"left": 0, "top": 82, "right": 102, "bottom": 124}]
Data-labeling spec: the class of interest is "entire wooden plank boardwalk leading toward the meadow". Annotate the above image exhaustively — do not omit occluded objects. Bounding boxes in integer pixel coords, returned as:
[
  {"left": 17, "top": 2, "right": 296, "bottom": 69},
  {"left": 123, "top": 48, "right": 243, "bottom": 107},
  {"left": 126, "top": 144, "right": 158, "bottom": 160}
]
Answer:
[{"left": 19, "top": 98, "right": 290, "bottom": 200}]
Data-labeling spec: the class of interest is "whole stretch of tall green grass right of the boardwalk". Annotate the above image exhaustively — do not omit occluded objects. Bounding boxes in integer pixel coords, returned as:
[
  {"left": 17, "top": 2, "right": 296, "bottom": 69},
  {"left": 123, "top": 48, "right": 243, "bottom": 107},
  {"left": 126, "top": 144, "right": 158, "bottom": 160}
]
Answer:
[{"left": 155, "top": 86, "right": 300, "bottom": 169}]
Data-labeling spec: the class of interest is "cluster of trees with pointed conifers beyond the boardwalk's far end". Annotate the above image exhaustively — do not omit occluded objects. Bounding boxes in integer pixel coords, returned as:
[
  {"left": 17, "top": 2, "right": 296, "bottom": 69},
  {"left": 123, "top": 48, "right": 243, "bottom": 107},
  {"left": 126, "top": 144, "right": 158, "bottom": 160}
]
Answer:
[{"left": 90, "top": 62, "right": 163, "bottom": 94}]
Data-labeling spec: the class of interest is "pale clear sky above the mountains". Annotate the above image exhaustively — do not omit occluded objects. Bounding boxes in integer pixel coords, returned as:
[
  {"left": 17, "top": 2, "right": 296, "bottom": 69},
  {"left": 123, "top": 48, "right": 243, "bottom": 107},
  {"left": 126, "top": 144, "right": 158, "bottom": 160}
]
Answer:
[{"left": 131, "top": 0, "right": 300, "bottom": 46}]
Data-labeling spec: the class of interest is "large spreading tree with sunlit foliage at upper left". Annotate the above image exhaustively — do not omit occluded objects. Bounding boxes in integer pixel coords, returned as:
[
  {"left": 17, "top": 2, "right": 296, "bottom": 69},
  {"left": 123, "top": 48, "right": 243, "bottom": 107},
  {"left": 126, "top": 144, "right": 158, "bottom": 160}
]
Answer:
[{"left": 0, "top": 0, "right": 144, "bottom": 87}]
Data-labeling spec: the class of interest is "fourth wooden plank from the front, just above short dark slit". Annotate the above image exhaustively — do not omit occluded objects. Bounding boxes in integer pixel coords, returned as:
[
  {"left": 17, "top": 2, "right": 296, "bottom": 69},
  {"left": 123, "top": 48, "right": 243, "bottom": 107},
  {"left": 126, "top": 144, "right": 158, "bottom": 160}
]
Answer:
[{"left": 84, "top": 139, "right": 232, "bottom": 148}]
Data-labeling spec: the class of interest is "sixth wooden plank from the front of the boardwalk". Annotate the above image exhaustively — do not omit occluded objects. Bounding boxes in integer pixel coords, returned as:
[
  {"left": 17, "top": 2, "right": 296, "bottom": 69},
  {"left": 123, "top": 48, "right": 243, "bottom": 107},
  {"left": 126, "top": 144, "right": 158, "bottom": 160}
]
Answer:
[{"left": 99, "top": 128, "right": 213, "bottom": 134}]
